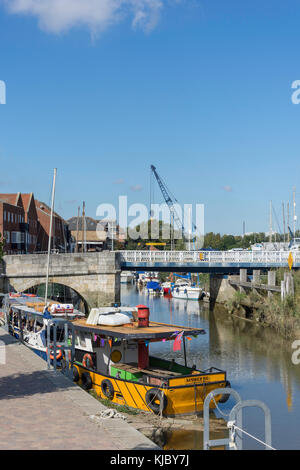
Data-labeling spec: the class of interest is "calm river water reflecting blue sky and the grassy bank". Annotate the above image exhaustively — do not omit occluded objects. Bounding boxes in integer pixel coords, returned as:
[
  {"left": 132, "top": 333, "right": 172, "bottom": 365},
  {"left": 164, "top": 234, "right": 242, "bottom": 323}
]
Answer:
[{"left": 121, "top": 284, "right": 300, "bottom": 449}]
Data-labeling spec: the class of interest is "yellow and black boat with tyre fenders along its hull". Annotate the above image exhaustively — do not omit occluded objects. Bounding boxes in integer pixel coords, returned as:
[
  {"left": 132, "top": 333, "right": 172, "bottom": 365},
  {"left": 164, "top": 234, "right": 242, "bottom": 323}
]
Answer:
[{"left": 73, "top": 305, "right": 230, "bottom": 417}]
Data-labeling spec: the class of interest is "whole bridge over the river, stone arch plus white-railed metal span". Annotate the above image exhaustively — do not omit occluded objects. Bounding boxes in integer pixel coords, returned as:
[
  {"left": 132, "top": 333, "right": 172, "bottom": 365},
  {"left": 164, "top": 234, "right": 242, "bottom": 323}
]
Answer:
[{"left": 0, "top": 250, "right": 300, "bottom": 308}]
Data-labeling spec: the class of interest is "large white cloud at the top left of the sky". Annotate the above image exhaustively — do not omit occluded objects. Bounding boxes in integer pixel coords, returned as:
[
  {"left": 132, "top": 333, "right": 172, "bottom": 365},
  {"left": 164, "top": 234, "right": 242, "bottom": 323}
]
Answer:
[{"left": 0, "top": 0, "right": 166, "bottom": 34}]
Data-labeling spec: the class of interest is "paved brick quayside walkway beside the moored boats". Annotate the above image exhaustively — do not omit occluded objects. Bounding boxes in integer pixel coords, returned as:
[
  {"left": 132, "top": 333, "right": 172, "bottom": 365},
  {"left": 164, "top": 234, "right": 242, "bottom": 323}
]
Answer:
[{"left": 0, "top": 328, "right": 158, "bottom": 450}]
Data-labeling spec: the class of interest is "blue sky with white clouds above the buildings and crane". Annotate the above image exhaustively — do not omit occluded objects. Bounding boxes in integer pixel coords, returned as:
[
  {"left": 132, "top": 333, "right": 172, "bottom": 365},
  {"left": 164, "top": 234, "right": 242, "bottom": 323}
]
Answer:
[{"left": 0, "top": 0, "right": 300, "bottom": 234}]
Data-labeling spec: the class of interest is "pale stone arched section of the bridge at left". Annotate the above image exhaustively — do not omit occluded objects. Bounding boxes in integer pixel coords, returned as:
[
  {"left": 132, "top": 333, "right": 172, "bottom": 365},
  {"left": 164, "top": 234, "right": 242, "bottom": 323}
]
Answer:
[{"left": 3, "top": 252, "right": 120, "bottom": 308}]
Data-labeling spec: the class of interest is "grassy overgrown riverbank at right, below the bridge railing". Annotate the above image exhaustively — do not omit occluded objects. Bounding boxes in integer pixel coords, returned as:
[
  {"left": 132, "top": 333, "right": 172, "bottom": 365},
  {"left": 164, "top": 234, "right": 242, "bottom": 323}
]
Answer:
[{"left": 224, "top": 269, "right": 300, "bottom": 339}]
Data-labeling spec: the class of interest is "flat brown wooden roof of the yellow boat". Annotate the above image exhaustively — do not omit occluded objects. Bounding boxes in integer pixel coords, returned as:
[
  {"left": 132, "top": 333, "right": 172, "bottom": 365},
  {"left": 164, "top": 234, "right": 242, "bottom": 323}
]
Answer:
[{"left": 73, "top": 319, "right": 205, "bottom": 340}]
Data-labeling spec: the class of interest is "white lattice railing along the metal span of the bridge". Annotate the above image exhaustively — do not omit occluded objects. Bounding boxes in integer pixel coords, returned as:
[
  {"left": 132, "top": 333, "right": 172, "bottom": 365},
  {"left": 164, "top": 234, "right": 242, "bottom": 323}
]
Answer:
[{"left": 119, "top": 250, "right": 300, "bottom": 266}]
